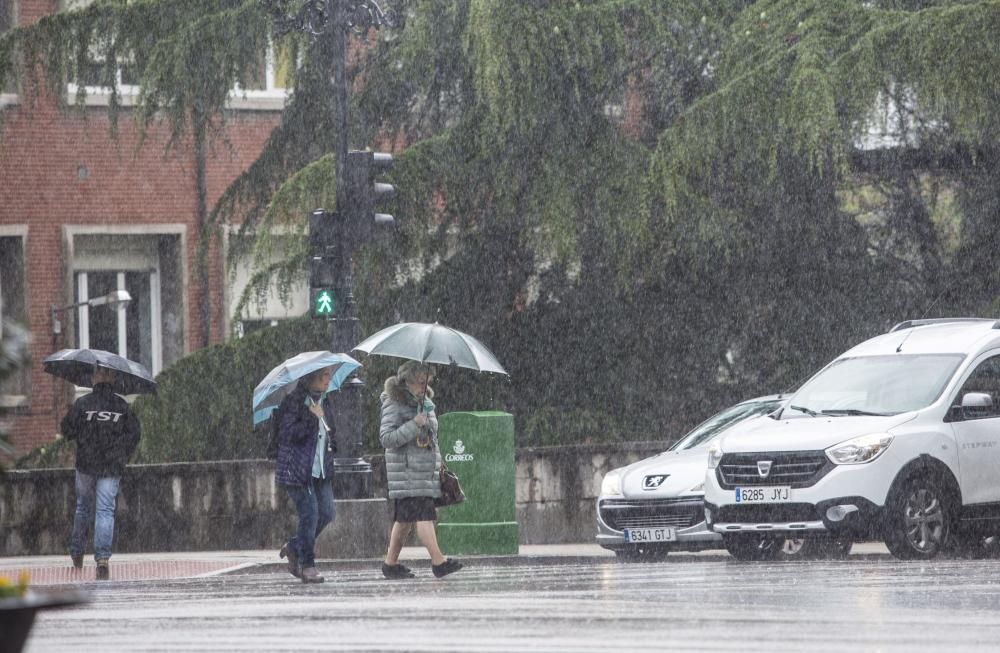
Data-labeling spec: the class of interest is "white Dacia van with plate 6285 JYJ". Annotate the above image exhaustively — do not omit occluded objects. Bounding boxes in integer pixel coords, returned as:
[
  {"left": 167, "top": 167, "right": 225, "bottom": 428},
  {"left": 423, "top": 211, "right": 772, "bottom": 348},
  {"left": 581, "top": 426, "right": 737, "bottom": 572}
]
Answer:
[{"left": 705, "top": 318, "right": 1000, "bottom": 560}]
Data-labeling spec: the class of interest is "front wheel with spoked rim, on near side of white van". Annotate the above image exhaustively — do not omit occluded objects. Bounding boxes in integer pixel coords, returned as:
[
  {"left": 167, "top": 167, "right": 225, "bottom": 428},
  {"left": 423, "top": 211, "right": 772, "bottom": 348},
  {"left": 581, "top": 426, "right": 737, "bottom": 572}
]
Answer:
[{"left": 885, "top": 476, "right": 952, "bottom": 560}]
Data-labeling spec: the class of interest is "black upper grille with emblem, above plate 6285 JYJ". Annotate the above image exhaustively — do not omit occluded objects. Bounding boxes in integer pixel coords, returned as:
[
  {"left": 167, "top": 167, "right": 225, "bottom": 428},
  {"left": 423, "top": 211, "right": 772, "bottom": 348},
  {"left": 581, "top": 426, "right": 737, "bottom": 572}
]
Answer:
[{"left": 718, "top": 451, "right": 833, "bottom": 489}]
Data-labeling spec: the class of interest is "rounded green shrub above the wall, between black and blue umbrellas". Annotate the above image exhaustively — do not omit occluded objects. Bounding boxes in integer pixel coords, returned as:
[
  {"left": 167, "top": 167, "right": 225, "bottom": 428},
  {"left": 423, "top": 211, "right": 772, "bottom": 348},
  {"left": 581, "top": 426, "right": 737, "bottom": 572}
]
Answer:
[{"left": 134, "top": 317, "right": 329, "bottom": 462}]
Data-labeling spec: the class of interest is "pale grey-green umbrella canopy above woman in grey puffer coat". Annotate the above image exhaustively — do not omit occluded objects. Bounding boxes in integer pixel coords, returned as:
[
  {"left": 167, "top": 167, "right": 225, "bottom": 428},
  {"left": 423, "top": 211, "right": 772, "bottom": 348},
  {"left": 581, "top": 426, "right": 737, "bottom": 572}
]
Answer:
[{"left": 354, "top": 322, "right": 507, "bottom": 374}]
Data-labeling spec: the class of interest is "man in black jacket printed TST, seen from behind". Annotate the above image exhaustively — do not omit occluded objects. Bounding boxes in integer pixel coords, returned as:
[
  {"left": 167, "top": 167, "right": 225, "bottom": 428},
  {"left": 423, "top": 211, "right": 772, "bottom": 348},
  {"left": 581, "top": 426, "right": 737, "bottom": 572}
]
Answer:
[{"left": 62, "top": 367, "right": 139, "bottom": 580}]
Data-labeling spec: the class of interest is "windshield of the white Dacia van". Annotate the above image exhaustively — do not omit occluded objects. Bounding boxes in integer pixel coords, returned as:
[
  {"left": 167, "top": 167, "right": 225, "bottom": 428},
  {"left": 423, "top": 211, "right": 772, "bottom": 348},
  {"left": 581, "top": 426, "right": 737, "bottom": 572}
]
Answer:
[{"left": 782, "top": 354, "right": 965, "bottom": 417}]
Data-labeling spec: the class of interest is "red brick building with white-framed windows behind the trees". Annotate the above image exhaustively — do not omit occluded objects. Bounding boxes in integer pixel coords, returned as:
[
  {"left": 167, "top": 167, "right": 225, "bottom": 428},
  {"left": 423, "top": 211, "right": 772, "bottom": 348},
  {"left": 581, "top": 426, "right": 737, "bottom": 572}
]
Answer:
[{"left": 0, "top": 0, "right": 305, "bottom": 452}]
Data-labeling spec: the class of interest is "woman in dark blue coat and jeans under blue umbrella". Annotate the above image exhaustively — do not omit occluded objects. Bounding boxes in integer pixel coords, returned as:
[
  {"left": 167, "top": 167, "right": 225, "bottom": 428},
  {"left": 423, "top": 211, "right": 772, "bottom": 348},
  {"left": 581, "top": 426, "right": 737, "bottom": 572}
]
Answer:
[{"left": 272, "top": 367, "right": 337, "bottom": 583}]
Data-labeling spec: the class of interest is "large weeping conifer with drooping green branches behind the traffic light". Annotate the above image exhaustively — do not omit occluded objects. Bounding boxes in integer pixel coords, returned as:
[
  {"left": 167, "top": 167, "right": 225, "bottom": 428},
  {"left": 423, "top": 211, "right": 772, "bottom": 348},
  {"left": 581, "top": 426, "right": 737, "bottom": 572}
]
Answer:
[{"left": 7, "top": 0, "right": 1000, "bottom": 455}]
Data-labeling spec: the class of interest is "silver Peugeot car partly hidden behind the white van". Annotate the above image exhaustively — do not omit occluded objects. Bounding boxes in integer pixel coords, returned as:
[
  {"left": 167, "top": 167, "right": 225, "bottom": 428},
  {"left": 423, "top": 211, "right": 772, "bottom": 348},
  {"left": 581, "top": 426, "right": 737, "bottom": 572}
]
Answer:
[{"left": 597, "top": 395, "right": 788, "bottom": 559}]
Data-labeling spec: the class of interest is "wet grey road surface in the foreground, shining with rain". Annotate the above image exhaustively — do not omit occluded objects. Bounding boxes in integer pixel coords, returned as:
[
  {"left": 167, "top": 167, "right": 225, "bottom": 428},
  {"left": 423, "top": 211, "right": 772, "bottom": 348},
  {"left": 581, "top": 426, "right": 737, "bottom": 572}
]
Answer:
[{"left": 26, "top": 556, "right": 1000, "bottom": 653}]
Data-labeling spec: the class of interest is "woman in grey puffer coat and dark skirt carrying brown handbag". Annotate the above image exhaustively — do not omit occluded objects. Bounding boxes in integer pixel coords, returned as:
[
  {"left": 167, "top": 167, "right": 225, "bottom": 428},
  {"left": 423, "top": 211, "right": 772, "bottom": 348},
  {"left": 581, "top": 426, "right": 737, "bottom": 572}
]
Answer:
[{"left": 379, "top": 361, "right": 462, "bottom": 578}]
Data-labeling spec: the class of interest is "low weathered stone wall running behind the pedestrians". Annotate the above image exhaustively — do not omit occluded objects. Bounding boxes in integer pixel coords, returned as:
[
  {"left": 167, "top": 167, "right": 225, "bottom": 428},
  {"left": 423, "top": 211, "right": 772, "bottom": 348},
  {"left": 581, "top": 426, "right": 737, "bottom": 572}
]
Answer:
[{"left": 0, "top": 442, "right": 665, "bottom": 557}]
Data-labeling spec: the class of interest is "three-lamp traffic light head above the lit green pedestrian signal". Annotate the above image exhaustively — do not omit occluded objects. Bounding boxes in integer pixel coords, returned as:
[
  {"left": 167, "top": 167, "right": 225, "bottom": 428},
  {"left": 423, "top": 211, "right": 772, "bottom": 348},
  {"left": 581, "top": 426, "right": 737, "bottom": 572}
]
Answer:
[{"left": 337, "top": 150, "right": 396, "bottom": 245}]
